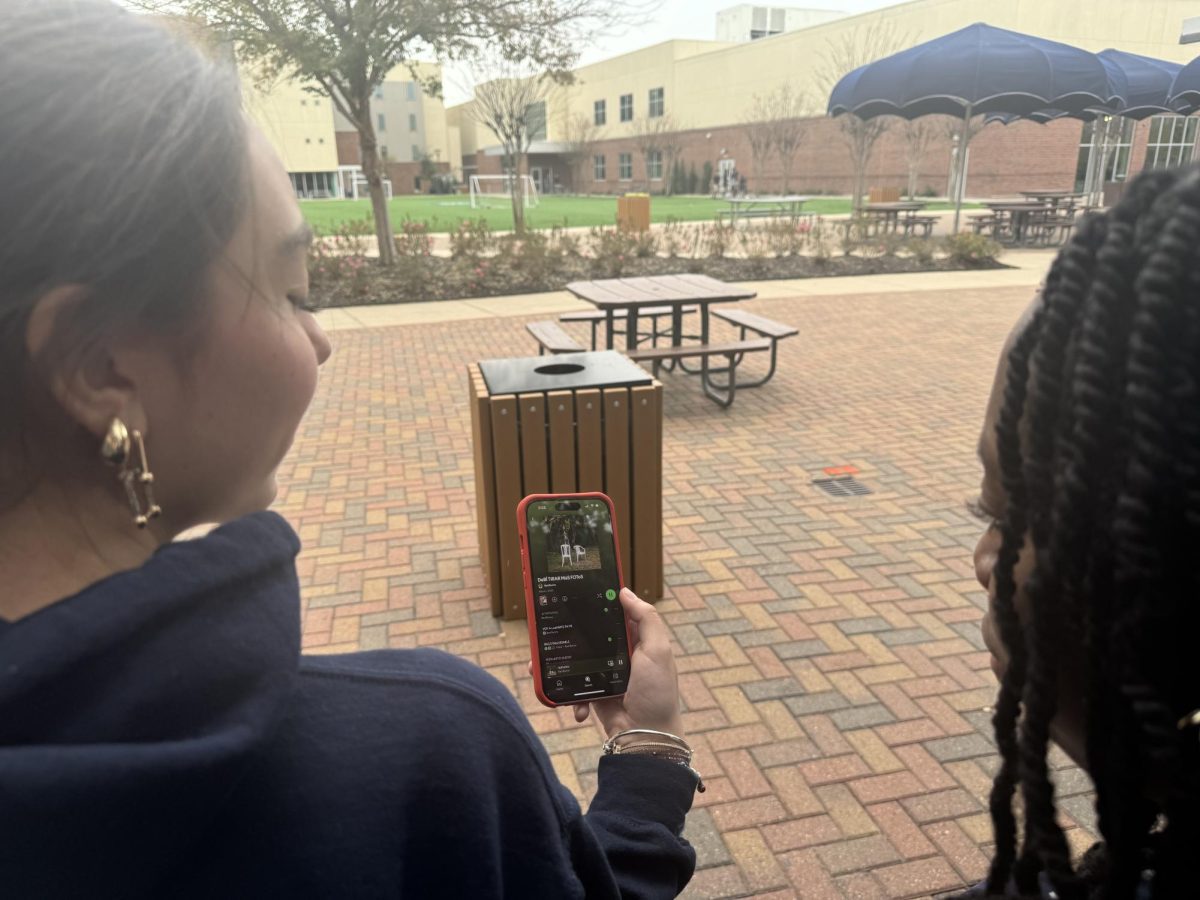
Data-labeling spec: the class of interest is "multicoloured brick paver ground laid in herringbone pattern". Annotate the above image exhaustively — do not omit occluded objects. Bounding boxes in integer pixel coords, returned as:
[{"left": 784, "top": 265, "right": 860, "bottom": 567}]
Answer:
[{"left": 278, "top": 288, "right": 1092, "bottom": 898}]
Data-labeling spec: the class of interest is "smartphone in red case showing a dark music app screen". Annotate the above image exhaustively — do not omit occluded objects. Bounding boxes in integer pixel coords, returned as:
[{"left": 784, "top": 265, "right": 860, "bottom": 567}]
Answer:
[{"left": 517, "top": 493, "right": 630, "bottom": 707}]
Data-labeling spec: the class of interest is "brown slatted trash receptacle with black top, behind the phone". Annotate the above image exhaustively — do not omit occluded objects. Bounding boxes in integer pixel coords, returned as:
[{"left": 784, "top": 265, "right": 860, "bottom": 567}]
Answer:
[{"left": 467, "top": 350, "right": 662, "bottom": 619}]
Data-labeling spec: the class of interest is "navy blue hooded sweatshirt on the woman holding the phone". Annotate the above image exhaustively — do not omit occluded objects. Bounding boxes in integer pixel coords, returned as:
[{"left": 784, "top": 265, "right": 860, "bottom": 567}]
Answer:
[{"left": 0, "top": 512, "right": 695, "bottom": 900}]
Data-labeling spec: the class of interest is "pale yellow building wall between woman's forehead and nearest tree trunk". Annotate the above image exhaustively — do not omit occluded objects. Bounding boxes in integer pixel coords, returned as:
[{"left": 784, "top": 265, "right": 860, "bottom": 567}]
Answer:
[{"left": 242, "top": 73, "right": 337, "bottom": 172}]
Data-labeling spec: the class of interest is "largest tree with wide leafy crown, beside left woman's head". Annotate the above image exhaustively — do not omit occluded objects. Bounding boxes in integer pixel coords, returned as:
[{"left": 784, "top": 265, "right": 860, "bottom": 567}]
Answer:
[{"left": 136, "top": 0, "right": 648, "bottom": 265}]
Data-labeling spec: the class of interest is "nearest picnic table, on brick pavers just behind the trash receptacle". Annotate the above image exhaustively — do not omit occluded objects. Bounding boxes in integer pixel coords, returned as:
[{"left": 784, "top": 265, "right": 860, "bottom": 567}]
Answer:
[{"left": 566, "top": 275, "right": 777, "bottom": 407}]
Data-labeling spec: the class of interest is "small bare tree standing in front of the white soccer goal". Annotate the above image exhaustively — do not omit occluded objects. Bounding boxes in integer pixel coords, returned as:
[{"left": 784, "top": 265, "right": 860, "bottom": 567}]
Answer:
[{"left": 469, "top": 56, "right": 552, "bottom": 234}]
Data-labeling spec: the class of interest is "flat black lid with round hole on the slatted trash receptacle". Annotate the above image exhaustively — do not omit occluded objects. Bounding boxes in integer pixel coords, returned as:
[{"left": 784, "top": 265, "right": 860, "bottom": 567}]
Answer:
[{"left": 479, "top": 350, "right": 654, "bottom": 396}]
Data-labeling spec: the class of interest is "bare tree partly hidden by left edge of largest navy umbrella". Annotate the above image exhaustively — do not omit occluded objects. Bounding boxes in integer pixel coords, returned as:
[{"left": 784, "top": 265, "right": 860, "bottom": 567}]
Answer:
[{"left": 816, "top": 22, "right": 912, "bottom": 215}]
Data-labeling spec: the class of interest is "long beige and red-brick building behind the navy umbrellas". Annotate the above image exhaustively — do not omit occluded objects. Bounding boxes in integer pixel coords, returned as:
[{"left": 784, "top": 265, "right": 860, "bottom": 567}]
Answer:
[{"left": 448, "top": 0, "right": 1198, "bottom": 197}]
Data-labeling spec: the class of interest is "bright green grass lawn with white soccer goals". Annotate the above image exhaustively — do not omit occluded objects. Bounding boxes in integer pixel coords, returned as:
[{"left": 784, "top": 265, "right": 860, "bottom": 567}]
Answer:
[{"left": 300, "top": 194, "right": 976, "bottom": 234}]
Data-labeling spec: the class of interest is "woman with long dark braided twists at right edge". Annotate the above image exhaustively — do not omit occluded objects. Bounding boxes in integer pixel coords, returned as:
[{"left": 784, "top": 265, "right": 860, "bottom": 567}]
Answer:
[{"left": 967, "top": 169, "right": 1200, "bottom": 900}]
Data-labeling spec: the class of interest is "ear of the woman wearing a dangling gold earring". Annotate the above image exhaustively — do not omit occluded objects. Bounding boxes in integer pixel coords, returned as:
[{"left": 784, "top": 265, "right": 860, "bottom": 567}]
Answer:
[{"left": 25, "top": 284, "right": 146, "bottom": 439}]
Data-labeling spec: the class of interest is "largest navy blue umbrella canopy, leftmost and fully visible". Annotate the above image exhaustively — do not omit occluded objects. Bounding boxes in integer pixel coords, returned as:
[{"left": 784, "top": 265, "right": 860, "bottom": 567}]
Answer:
[{"left": 829, "top": 23, "right": 1112, "bottom": 119}]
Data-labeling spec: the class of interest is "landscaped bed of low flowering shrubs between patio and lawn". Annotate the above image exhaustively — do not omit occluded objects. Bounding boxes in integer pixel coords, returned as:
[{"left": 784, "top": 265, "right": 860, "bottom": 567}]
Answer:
[{"left": 310, "top": 221, "right": 1002, "bottom": 307}]
